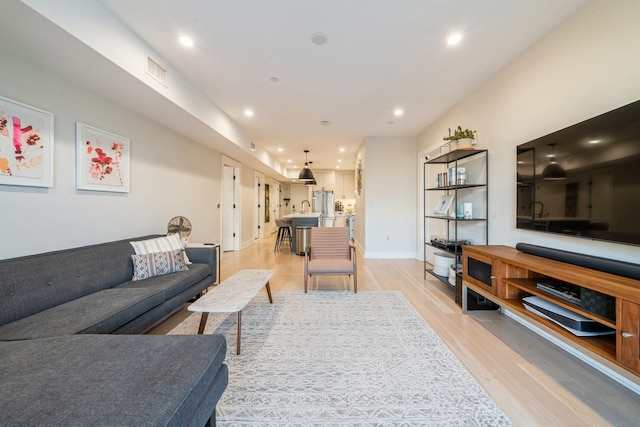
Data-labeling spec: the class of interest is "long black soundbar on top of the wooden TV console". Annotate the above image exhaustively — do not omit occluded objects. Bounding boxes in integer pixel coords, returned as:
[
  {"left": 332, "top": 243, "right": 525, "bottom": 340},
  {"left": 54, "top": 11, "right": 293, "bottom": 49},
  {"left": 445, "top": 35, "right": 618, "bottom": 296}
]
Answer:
[{"left": 516, "top": 243, "right": 640, "bottom": 280}]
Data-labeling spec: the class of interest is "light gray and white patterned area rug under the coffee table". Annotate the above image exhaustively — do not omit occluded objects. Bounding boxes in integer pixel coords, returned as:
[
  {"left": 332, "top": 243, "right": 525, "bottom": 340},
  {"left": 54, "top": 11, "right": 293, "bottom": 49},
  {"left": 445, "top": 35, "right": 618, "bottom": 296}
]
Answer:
[{"left": 170, "top": 291, "right": 511, "bottom": 427}]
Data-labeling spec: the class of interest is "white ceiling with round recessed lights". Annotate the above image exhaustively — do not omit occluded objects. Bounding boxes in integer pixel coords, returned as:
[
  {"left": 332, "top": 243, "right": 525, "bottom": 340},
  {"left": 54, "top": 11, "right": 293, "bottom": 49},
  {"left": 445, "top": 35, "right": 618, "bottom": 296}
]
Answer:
[{"left": 5, "top": 0, "right": 586, "bottom": 177}]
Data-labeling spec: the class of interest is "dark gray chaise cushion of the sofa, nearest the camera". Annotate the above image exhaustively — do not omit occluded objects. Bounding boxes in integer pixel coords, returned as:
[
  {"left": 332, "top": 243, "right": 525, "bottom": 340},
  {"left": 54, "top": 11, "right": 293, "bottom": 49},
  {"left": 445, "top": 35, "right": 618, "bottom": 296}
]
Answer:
[{"left": 0, "top": 335, "right": 228, "bottom": 426}]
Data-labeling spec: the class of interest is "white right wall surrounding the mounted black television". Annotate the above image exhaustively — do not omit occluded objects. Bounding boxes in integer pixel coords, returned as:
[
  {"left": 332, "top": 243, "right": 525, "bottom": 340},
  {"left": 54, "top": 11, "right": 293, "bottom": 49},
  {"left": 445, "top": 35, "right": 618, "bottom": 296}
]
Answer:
[{"left": 418, "top": 0, "right": 640, "bottom": 263}]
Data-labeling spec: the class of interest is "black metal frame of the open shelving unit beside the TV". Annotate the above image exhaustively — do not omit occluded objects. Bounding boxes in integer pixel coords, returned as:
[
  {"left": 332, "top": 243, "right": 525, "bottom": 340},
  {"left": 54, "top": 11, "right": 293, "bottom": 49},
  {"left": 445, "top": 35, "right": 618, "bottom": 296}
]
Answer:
[{"left": 423, "top": 150, "right": 489, "bottom": 304}]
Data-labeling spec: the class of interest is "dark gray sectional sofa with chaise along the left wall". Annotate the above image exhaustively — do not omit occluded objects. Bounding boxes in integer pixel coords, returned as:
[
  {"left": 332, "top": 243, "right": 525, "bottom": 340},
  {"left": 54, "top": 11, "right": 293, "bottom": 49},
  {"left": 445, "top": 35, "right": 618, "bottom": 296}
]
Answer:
[{"left": 0, "top": 236, "right": 228, "bottom": 426}]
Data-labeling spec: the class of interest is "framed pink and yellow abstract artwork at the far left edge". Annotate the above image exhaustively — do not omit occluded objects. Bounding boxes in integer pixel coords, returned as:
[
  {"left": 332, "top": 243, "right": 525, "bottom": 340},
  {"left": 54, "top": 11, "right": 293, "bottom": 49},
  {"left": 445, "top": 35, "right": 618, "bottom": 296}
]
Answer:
[{"left": 0, "top": 96, "right": 53, "bottom": 188}]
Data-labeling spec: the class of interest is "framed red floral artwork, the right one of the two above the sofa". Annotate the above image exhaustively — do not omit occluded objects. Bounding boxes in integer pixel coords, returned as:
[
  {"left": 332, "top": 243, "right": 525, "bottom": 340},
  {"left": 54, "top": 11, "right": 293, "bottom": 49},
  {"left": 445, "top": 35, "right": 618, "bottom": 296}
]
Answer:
[{"left": 76, "top": 122, "right": 131, "bottom": 193}]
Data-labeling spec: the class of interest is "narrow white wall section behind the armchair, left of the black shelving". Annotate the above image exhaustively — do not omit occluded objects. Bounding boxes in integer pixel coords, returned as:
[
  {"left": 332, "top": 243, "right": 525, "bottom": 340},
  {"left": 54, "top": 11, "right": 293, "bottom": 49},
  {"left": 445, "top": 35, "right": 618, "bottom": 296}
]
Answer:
[{"left": 356, "top": 137, "right": 418, "bottom": 258}]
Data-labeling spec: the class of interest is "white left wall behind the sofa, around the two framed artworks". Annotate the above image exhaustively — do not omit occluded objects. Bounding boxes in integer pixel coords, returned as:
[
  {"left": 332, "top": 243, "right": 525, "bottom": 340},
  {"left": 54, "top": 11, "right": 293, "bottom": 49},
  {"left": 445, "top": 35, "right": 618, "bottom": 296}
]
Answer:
[{"left": 0, "top": 46, "right": 221, "bottom": 259}]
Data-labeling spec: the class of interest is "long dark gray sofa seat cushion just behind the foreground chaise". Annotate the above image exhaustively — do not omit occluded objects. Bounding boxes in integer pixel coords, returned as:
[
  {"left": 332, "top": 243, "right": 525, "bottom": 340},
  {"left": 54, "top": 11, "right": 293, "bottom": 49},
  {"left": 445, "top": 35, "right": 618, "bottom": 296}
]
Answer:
[{"left": 0, "top": 288, "right": 166, "bottom": 340}]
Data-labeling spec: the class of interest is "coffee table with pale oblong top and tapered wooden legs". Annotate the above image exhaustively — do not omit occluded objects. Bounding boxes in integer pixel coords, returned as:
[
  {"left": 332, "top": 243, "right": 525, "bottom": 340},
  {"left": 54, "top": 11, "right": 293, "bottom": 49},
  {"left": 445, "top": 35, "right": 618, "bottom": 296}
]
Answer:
[{"left": 188, "top": 270, "right": 273, "bottom": 354}]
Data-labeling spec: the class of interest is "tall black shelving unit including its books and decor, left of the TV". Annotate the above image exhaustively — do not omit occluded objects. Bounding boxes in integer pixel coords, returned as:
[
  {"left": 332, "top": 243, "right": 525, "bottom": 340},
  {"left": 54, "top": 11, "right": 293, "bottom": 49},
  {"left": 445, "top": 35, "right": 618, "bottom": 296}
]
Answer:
[{"left": 424, "top": 149, "right": 489, "bottom": 304}]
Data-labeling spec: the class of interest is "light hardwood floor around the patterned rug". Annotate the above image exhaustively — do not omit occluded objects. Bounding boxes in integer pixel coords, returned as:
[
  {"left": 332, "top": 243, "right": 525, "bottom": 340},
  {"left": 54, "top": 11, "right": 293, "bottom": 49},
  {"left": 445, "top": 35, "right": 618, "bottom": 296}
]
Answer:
[{"left": 150, "top": 235, "right": 640, "bottom": 426}]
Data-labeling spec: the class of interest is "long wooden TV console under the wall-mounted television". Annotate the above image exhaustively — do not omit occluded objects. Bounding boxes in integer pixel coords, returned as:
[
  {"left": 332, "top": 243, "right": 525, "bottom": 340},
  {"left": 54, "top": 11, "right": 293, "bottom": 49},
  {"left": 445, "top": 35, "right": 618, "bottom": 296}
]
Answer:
[{"left": 462, "top": 245, "right": 640, "bottom": 376}]
